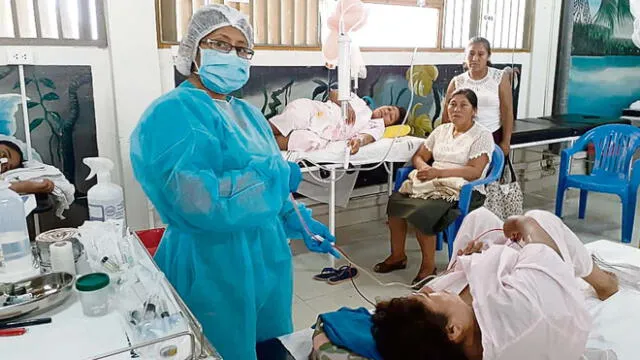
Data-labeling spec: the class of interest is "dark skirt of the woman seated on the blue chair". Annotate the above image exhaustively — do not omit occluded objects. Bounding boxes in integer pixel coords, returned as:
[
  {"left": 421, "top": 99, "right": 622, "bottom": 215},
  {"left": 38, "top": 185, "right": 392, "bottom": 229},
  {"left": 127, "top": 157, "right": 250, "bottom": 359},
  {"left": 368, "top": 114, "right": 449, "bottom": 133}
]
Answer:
[{"left": 387, "top": 190, "right": 485, "bottom": 235}]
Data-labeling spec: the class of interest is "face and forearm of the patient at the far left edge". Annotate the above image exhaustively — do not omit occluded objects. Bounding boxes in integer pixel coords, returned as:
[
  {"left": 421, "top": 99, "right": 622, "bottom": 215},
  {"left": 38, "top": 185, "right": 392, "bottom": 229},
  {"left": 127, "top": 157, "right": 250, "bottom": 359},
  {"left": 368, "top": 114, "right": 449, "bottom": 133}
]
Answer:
[{"left": 0, "top": 141, "right": 55, "bottom": 194}]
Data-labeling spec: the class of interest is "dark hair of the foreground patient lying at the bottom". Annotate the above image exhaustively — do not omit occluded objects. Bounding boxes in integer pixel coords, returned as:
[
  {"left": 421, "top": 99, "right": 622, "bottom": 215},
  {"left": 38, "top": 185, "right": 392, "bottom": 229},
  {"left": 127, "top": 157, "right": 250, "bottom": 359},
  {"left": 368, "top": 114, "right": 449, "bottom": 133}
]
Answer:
[{"left": 371, "top": 297, "right": 468, "bottom": 360}]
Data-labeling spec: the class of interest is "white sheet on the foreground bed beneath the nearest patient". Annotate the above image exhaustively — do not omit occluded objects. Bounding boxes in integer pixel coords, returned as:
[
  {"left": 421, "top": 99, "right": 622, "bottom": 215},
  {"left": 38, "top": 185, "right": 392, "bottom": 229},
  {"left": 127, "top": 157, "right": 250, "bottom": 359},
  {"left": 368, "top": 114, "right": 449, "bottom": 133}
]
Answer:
[{"left": 279, "top": 240, "right": 640, "bottom": 360}]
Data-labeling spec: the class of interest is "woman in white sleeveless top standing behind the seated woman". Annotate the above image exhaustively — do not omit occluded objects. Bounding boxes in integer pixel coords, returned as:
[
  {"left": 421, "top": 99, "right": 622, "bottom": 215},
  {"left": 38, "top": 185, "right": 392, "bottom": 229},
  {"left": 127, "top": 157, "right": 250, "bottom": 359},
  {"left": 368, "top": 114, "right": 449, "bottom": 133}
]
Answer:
[{"left": 442, "top": 37, "right": 513, "bottom": 155}]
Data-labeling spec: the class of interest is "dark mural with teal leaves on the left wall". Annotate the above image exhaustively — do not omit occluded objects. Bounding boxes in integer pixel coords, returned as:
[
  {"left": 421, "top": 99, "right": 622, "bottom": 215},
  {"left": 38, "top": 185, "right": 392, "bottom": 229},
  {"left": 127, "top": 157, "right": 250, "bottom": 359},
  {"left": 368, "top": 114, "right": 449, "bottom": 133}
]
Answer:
[{"left": 0, "top": 65, "right": 98, "bottom": 229}]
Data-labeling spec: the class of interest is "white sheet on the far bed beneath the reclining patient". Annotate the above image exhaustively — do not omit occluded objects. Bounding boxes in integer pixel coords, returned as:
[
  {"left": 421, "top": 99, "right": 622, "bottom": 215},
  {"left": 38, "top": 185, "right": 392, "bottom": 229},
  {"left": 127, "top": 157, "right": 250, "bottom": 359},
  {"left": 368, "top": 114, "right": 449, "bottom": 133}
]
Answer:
[{"left": 282, "top": 136, "right": 425, "bottom": 165}]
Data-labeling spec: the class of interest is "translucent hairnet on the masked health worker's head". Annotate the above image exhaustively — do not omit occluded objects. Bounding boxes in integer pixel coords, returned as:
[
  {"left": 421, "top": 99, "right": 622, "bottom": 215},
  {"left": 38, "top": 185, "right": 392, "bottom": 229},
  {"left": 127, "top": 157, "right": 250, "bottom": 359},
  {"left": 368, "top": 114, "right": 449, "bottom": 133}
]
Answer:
[{"left": 176, "top": 5, "right": 253, "bottom": 76}]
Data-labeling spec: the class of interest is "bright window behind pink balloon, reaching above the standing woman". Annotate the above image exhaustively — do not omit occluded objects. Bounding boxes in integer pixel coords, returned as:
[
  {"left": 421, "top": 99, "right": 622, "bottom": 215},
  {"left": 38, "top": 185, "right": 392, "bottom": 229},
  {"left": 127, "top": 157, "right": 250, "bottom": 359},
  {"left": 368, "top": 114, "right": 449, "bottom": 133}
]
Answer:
[{"left": 321, "top": 0, "right": 534, "bottom": 50}]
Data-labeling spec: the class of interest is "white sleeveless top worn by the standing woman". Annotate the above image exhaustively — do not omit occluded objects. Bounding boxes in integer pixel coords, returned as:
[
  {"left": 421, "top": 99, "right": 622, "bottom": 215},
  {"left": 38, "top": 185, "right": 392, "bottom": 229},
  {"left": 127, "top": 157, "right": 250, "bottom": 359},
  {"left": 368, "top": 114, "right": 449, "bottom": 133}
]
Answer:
[{"left": 453, "top": 67, "right": 504, "bottom": 132}]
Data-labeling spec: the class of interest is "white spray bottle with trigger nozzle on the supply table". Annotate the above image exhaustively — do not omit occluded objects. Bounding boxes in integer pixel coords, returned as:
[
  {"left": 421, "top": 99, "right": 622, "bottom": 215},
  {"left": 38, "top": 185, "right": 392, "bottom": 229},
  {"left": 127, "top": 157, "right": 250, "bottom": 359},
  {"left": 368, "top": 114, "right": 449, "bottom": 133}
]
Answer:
[{"left": 83, "top": 157, "right": 125, "bottom": 227}]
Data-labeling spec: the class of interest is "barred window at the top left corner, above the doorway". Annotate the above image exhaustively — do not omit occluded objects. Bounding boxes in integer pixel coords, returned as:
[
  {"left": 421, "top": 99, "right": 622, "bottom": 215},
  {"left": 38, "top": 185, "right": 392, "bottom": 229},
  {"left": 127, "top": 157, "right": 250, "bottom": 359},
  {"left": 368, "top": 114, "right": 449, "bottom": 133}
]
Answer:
[{"left": 0, "top": 0, "right": 107, "bottom": 47}]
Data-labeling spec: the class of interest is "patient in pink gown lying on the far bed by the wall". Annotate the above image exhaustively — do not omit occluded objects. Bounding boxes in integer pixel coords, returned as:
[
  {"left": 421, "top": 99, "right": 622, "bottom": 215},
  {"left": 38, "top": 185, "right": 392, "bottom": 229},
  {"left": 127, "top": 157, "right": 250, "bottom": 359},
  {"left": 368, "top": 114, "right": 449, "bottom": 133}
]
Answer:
[{"left": 269, "top": 91, "right": 406, "bottom": 154}]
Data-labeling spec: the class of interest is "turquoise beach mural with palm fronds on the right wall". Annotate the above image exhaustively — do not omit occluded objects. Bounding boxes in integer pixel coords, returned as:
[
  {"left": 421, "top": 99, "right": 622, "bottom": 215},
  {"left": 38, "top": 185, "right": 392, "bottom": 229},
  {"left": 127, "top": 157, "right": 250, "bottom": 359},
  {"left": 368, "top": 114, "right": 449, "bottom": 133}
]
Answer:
[{"left": 567, "top": 0, "right": 640, "bottom": 117}]
